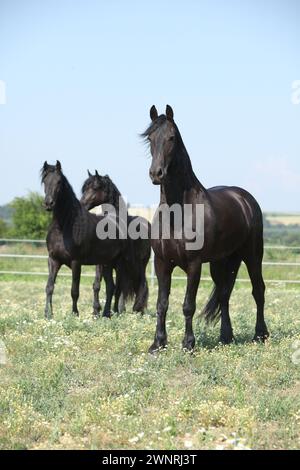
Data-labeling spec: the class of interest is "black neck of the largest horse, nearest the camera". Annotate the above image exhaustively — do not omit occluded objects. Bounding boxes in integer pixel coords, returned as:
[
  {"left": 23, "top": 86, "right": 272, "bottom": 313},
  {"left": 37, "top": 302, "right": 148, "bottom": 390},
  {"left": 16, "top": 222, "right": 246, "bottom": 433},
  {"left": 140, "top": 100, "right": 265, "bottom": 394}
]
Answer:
[{"left": 160, "top": 141, "right": 206, "bottom": 205}]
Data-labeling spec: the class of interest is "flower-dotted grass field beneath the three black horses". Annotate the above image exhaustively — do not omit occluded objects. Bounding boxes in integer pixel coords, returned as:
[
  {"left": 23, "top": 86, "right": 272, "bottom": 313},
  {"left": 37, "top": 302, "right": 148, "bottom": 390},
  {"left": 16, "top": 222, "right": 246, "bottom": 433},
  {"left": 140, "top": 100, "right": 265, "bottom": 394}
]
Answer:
[{"left": 0, "top": 278, "right": 300, "bottom": 449}]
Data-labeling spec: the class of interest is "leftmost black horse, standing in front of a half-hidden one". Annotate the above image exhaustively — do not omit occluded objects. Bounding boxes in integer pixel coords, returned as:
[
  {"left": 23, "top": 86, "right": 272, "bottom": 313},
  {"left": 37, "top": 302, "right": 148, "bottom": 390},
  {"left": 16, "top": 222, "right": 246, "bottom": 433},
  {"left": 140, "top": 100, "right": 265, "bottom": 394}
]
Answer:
[{"left": 41, "top": 162, "right": 136, "bottom": 318}]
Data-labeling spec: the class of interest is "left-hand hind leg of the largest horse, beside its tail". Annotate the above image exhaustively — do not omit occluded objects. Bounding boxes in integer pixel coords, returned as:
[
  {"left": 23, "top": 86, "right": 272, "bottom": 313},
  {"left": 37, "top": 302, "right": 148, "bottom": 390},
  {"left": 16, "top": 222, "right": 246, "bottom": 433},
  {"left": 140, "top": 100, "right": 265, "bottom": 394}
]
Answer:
[{"left": 210, "top": 254, "right": 241, "bottom": 344}]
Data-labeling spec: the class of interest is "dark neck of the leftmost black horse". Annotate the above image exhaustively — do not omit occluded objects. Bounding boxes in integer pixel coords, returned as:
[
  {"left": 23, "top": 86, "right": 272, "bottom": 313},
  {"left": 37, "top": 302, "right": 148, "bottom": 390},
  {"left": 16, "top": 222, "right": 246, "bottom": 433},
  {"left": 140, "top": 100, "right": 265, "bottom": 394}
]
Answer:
[{"left": 53, "top": 179, "right": 82, "bottom": 230}]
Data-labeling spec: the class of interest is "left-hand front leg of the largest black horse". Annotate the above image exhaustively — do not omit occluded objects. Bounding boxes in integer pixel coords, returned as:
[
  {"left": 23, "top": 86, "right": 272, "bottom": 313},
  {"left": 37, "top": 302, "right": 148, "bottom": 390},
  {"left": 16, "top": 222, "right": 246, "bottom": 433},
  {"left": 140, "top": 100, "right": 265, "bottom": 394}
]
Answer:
[{"left": 149, "top": 256, "right": 173, "bottom": 353}]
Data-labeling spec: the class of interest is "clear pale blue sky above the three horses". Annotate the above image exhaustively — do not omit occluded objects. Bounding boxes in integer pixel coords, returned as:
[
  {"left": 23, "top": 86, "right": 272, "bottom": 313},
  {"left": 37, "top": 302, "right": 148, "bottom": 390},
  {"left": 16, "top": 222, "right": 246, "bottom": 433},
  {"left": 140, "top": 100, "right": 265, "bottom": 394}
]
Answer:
[{"left": 0, "top": 0, "right": 300, "bottom": 212}]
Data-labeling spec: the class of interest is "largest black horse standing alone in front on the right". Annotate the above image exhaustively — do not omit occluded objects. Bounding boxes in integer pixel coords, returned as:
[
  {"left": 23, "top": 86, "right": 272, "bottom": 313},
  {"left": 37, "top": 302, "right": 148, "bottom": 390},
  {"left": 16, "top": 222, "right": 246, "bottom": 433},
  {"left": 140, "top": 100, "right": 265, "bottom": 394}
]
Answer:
[{"left": 142, "top": 105, "right": 269, "bottom": 352}]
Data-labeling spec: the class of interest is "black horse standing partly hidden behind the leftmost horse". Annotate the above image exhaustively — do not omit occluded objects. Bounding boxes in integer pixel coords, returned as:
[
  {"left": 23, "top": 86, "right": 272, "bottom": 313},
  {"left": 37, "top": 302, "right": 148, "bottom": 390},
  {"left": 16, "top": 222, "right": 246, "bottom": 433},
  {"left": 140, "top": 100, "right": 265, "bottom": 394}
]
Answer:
[{"left": 80, "top": 170, "right": 151, "bottom": 312}]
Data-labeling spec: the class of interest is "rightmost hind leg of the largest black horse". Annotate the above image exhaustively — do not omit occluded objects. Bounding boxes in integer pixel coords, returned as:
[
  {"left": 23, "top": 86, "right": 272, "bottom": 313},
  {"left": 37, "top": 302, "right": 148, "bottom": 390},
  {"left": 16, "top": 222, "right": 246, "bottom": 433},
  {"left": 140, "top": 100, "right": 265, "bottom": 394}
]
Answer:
[{"left": 244, "top": 240, "right": 269, "bottom": 342}]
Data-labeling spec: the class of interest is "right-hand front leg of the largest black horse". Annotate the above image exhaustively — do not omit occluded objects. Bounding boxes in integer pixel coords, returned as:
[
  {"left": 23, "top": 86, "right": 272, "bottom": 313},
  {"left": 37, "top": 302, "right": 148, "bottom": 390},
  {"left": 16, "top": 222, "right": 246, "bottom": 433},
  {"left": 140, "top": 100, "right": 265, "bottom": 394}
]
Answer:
[{"left": 182, "top": 261, "right": 202, "bottom": 351}]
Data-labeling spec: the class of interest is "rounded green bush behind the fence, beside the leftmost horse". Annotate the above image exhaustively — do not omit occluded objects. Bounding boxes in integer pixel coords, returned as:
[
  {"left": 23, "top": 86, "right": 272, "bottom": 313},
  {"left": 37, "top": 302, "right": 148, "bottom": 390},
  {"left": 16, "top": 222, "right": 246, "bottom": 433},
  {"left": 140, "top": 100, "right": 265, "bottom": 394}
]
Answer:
[{"left": 10, "top": 192, "right": 51, "bottom": 239}]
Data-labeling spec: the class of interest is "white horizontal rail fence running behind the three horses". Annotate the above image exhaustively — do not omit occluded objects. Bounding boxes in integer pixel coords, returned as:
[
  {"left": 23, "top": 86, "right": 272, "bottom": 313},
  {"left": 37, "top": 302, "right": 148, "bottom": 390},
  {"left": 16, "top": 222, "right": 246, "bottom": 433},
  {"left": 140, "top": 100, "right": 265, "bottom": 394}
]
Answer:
[{"left": 0, "top": 238, "right": 300, "bottom": 285}]
